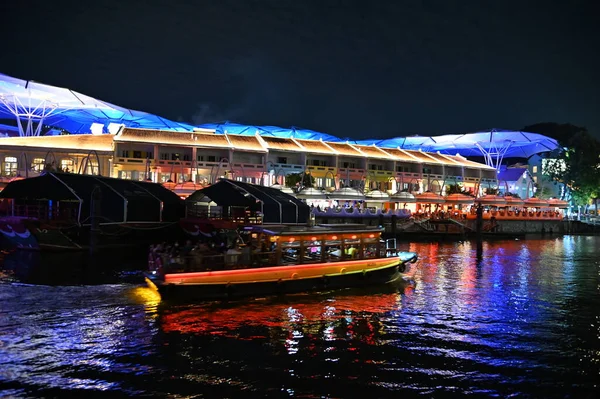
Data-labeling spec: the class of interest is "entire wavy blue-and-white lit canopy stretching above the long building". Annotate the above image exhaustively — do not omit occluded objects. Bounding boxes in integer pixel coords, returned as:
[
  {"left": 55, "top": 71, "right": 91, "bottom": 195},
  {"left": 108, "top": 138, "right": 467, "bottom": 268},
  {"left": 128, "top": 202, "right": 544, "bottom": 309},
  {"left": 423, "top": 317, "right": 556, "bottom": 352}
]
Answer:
[{"left": 0, "top": 74, "right": 558, "bottom": 169}]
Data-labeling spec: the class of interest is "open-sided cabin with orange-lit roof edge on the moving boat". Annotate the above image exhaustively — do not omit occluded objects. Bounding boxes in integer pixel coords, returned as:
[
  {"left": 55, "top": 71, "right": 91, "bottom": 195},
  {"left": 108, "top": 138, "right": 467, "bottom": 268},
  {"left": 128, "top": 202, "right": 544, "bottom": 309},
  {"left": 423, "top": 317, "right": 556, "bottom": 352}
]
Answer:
[{"left": 248, "top": 224, "right": 386, "bottom": 265}]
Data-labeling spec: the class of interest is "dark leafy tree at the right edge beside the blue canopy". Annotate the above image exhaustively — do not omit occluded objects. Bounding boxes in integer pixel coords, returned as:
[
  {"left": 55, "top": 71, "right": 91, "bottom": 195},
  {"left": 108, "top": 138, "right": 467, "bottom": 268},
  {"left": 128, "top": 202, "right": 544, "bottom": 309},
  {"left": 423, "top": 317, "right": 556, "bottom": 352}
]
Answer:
[{"left": 523, "top": 123, "right": 600, "bottom": 205}]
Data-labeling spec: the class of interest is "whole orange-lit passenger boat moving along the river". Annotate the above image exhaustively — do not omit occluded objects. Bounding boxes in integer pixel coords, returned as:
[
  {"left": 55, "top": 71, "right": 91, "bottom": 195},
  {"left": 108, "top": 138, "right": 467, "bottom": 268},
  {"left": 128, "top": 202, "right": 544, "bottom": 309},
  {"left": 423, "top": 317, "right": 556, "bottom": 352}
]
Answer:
[{"left": 146, "top": 224, "right": 417, "bottom": 299}]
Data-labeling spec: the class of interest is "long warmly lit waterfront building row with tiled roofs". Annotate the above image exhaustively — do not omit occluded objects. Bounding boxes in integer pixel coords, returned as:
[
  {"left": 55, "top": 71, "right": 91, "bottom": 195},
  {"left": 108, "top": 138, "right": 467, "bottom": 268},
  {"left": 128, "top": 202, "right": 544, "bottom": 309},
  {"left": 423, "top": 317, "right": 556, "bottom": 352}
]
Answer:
[{"left": 0, "top": 127, "right": 498, "bottom": 194}]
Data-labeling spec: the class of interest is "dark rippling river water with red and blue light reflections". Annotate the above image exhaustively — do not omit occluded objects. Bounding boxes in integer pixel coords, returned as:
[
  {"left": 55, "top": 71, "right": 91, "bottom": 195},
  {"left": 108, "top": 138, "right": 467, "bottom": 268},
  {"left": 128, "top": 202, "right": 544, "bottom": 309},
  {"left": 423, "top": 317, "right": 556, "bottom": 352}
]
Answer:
[{"left": 0, "top": 237, "right": 600, "bottom": 398}]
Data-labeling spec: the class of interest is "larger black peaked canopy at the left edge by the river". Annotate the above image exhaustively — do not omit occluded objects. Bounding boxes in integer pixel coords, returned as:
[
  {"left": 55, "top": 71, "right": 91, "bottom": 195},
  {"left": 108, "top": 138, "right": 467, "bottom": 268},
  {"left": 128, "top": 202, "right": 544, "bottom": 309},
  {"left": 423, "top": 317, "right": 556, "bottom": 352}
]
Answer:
[{"left": 0, "top": 173, "right": 185, "bottom": 224}]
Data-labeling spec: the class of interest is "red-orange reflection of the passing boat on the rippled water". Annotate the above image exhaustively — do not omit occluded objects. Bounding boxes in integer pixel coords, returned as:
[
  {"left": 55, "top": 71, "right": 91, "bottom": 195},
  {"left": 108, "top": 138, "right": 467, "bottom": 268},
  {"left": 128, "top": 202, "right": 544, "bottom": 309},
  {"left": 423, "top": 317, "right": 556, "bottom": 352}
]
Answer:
[{"left": 155, "top": 282, "right": 414, "bottom": 340}]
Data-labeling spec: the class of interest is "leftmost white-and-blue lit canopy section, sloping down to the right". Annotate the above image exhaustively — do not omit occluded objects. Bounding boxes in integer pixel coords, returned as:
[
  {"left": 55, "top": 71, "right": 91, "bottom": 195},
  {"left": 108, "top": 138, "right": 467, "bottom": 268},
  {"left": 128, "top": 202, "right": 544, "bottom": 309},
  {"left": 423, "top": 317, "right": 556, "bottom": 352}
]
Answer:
[{"left": 0, "top": 74, "right": 194, "bottom": 136}]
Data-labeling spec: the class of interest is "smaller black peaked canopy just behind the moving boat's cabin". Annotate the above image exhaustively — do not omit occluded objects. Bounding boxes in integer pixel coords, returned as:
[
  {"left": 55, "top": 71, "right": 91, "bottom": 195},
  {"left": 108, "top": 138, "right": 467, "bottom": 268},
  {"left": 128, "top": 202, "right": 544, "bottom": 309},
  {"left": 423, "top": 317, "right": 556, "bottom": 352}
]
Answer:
[{"left": 187, "top": 179, "right": 310, "bottom": 224}]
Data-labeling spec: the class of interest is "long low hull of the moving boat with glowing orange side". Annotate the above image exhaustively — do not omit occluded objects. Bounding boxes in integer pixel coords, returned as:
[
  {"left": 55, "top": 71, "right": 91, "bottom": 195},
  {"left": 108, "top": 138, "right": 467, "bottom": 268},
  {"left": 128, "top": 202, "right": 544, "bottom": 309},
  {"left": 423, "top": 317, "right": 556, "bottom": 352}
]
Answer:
[{"left": 146, "top": 255, "right": 416, "bottom": 300}]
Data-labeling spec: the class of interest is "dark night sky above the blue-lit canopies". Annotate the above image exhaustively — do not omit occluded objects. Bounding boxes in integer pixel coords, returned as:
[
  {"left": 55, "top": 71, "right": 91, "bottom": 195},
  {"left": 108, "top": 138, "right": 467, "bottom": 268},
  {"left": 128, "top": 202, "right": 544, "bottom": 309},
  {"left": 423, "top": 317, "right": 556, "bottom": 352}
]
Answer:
[{"left": 0, "top": 0, "right": 600, "bottom": 138}]
